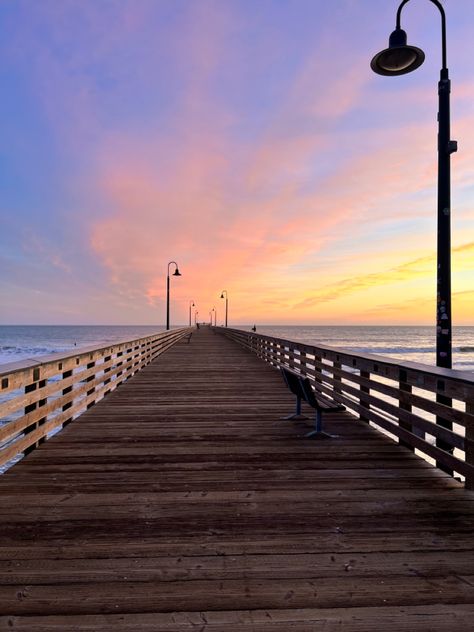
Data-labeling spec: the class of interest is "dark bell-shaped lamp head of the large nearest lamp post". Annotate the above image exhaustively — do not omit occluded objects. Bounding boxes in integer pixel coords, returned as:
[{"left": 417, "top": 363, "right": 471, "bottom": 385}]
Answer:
[{"left": 370, "top": 28, "right": 425, "bottom": 77}]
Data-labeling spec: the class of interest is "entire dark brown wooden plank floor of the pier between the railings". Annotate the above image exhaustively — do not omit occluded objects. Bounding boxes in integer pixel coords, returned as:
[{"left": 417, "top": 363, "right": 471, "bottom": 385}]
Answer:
[{"left": 0, "top": 329, "right": 474, "bottom": 632}]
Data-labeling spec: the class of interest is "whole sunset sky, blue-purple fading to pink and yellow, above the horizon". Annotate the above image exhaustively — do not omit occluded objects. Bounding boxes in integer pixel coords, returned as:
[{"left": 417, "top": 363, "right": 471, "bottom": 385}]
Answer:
[{"left": 0, "top": 0, "right": 474, "bottom": 326}]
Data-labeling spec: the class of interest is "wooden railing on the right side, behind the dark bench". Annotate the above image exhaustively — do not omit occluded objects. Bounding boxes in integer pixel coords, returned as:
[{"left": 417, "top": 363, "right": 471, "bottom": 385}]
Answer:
[{"left": 215, "top": 327, "right": 474, "bottom": 489}]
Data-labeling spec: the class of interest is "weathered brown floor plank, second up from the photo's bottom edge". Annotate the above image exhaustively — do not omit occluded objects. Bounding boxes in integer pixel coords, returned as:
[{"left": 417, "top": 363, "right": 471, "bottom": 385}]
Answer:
[{"left": 0, "top": 571, "right": 474, "bottom": 615}]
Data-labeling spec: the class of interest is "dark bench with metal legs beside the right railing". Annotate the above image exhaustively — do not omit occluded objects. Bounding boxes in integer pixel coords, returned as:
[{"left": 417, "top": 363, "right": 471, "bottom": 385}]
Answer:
[{"left": 281, "top": 367, "right": 346, "bottom": 439}]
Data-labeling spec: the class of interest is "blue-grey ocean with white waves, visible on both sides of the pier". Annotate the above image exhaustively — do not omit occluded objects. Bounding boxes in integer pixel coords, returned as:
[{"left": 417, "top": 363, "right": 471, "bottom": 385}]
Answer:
[{"left": 0, "top": 325, "right": 474, "bottom": 371}]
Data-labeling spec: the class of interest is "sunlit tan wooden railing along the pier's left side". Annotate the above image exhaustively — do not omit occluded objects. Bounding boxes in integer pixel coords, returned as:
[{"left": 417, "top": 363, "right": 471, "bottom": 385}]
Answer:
[{"left": 0, "top": 327, "right": 191, "bottom": 468}]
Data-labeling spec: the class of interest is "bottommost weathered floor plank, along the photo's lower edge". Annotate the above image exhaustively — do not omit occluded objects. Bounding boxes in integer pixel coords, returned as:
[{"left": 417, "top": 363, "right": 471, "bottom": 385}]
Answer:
[{"left": 0, "top": 604, "right": 474, "bottom": 632}]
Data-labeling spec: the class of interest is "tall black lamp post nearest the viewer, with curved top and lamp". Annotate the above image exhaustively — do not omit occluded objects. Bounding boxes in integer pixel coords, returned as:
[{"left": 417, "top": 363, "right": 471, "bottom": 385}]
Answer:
[{"left": 370, "top": 0, "right": 457, "bottom": 369}]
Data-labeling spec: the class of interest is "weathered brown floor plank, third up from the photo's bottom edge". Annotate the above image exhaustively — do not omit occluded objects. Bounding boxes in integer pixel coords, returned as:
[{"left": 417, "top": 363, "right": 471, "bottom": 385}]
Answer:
[{"left": 0, "top": 551, "right": 473, "bottom": 585}]
